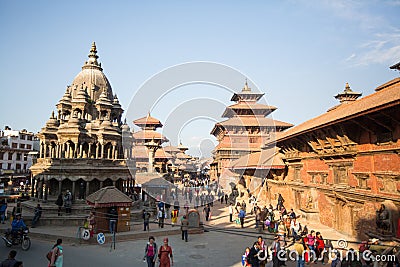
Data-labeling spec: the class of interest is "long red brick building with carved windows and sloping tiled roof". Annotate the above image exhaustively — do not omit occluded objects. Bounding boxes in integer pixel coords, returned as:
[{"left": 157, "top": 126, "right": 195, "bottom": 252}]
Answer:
[{"left": 265, "top": 68, "right": 400, "bottom": 238}]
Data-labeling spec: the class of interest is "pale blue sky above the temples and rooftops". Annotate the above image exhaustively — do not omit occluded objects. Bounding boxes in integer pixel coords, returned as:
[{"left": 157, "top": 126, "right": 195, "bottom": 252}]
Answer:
[{"left": 0, "top": 0, "right": 400, "bottom": 157}]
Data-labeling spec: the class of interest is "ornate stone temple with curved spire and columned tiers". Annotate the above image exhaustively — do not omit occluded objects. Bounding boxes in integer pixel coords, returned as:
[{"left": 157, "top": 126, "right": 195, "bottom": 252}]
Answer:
[{"left": 30, "top": 43, "right": 133, "bottom": 200}]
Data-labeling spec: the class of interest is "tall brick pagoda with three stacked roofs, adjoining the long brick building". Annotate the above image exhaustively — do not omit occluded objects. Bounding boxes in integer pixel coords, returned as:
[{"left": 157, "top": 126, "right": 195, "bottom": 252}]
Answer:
[{"left": 210, "top": 81, "right": 293, "bottom": 182}]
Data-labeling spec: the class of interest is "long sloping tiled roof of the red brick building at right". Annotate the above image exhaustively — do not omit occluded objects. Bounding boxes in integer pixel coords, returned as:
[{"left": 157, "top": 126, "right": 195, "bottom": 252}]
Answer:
[{"left": 276, "top": 78, "right": 400, "bottom": 142}]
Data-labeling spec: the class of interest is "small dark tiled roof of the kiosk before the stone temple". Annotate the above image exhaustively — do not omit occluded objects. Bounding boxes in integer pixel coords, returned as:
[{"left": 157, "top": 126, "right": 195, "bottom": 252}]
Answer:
[{"left": 86, "top": 186, "right": 132, "bottom": 207}]
